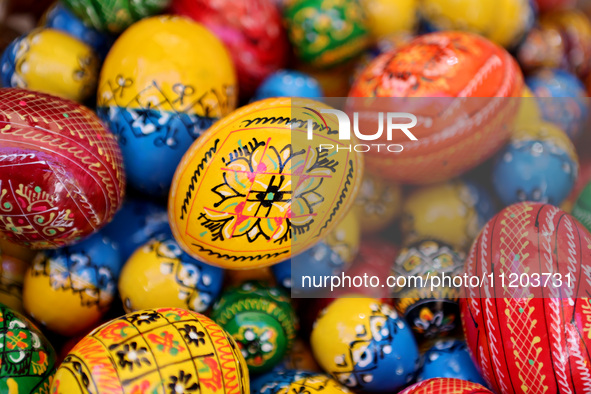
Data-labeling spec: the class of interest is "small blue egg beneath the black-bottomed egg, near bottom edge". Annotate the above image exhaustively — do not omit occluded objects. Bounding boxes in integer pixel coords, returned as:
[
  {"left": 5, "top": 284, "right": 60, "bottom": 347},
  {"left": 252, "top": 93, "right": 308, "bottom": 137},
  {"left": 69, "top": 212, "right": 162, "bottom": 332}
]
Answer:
[{"left": 417, "top": 340, "right": 487, "bottom": 387}]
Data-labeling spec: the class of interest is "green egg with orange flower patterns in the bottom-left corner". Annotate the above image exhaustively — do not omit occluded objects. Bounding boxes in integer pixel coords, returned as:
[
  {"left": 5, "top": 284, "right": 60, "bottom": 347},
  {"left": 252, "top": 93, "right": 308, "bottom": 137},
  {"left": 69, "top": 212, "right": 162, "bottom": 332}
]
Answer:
[{"left": 0, "top": 305, "right": 56, "bottom": 394}]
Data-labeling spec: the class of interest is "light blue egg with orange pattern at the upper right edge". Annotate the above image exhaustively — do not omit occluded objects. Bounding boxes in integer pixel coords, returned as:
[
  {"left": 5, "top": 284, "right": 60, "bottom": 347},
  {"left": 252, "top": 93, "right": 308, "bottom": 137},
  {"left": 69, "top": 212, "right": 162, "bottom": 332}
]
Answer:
[{"left": 525, "top": 69, "right": 589, "bottom": 141}]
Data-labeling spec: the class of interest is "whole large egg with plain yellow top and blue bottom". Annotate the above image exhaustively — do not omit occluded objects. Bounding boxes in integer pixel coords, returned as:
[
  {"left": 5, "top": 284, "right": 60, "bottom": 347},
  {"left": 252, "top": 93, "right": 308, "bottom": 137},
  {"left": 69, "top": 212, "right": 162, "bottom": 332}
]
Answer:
[{"left": 97, "top": 16, "right": 236, "bottom": 196}]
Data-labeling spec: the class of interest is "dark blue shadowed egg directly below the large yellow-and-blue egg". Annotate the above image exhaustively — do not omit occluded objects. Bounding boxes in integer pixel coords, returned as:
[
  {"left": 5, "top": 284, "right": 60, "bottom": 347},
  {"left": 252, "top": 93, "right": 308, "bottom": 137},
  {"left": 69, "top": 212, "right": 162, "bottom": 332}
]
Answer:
[{"left": 101, "top": 198, "right": 172, "bottom": 261}]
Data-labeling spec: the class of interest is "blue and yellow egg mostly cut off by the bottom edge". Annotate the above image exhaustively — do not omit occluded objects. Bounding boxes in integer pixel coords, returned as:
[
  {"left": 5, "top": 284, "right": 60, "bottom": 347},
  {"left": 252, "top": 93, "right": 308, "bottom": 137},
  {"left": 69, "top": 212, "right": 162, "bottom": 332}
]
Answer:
[{"left": 252, "top": 369, "right": 352, "bottom": 394}]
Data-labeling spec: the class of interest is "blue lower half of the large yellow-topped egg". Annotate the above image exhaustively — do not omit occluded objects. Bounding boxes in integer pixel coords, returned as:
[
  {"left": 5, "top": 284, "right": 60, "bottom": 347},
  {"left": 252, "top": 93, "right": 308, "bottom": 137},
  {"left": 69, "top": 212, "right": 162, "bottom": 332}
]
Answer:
[{"left": 97, "top": 106, "right": 217, "bottom": 197}]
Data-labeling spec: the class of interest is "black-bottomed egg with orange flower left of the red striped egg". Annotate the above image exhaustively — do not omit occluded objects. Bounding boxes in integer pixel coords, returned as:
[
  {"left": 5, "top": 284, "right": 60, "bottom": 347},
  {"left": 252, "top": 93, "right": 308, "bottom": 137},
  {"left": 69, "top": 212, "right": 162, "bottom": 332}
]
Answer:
[{"left": 391, "top": 240, "right": 466, "bottom": 342}]
